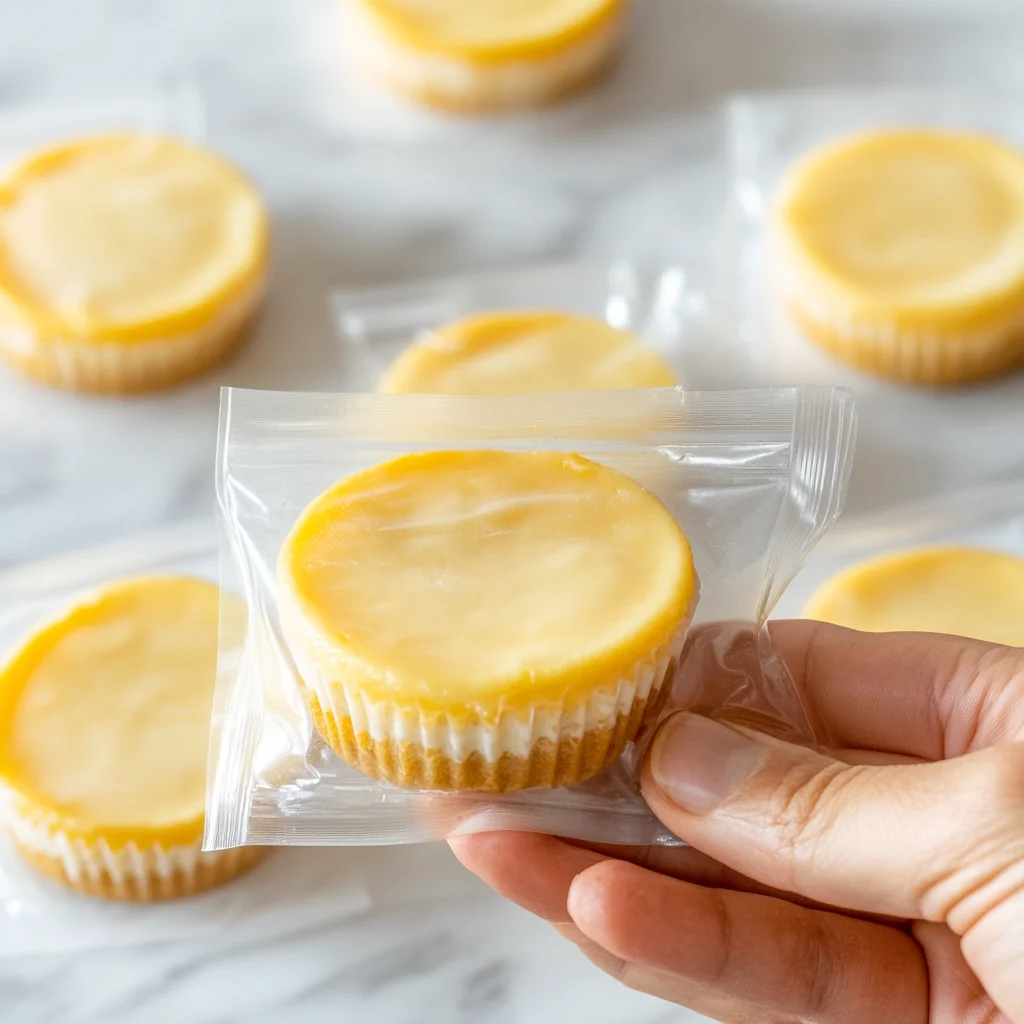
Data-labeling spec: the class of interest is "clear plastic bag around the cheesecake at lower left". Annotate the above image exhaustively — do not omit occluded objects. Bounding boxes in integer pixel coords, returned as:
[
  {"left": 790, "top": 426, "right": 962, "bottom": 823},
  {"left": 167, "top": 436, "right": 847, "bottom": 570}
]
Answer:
[{"left": 0, "top": 523, "right": 370, "bottom": 958}]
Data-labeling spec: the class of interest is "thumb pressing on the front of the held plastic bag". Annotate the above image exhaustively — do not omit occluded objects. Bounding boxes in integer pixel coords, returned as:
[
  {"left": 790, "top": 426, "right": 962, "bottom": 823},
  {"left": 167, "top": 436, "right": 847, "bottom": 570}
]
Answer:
[{"left": 641, "top": 714, "right": 1024, "bottom": 934}]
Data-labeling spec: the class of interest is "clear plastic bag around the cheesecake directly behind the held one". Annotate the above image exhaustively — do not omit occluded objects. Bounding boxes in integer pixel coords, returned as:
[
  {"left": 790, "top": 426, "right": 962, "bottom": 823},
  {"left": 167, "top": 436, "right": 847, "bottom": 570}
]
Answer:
[{"left": 331, "top": 260, "right": 735, "bottom": 391}]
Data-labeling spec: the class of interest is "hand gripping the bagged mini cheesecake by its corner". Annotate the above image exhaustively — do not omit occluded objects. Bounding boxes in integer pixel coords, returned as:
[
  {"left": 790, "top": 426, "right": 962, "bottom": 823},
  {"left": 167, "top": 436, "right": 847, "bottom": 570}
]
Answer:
[{"left": 451, "top": 622, "right": 1024, "bottom": 1024}]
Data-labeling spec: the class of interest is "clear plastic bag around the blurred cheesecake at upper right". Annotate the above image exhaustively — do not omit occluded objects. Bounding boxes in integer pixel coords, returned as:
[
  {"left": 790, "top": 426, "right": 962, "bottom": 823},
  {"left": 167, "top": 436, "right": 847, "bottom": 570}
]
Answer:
[{"left": 712, "top": 88, "right": 1024, "bottom": 385}]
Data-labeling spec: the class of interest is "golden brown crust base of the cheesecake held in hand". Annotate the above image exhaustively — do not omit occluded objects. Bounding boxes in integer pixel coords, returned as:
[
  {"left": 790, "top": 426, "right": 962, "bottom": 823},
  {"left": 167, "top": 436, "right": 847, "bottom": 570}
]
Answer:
[{"left": 306, "top": 692, "right": 647, "bottom": 793}]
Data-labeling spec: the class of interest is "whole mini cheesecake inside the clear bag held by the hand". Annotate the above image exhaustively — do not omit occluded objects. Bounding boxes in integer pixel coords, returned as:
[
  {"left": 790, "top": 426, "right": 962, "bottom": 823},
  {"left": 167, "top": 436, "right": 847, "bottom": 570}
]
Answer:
[{"left": 278, "top": 451, "right": 696, "bottom": 793}]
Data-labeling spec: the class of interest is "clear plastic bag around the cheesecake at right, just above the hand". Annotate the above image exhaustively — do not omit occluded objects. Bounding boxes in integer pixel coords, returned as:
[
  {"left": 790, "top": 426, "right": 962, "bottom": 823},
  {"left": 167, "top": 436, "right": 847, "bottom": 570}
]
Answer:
[{"left": 775, "top": 476, "right": 1024, "bottom": 617}]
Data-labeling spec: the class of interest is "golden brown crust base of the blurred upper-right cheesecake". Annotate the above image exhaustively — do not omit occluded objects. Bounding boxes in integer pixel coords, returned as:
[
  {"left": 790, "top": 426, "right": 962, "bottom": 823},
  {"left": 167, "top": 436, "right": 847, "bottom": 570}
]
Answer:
[{"left": 787, "top": 301, "right": 1024, "bottom": 387}]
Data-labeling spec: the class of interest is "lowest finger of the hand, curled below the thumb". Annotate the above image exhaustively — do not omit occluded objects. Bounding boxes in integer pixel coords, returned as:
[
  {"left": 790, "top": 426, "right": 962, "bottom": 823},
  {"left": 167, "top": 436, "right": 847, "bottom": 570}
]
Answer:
[{"left": 568, "top": 860, "right": 928, "bottom": 1024}]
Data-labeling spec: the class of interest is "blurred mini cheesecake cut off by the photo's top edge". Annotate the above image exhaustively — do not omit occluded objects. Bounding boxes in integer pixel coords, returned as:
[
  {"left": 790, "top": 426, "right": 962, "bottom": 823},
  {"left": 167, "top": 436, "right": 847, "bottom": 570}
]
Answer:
[{"left": 345, "top": 0, "right": 626, "bottom": 113}]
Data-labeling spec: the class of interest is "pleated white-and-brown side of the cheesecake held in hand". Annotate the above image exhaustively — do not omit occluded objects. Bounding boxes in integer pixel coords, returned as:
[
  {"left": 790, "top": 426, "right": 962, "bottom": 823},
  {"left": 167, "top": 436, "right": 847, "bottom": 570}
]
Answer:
[{"left": 300, "top": 617, "right": 689, "bottom": 792}]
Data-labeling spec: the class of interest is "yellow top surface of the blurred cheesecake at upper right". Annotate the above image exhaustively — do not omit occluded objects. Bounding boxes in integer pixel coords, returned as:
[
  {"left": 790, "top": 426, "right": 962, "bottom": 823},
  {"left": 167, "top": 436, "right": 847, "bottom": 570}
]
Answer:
[{"left": 778, "top": 129, "right": 1024, "bottom": 326}]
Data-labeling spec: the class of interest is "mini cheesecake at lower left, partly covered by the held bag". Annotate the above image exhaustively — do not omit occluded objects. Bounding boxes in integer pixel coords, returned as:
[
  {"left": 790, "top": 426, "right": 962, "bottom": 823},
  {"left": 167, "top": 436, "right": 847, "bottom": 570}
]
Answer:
[{"left": 0, "top": 578, "right": 262, "bottom": 901}]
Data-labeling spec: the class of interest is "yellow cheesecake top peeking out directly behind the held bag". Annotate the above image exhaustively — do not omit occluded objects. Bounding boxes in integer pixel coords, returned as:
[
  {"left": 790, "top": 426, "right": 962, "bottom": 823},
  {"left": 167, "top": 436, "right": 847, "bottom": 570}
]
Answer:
[{"left": 381, "top": 311, "right": 678, "bottom": 394}]
